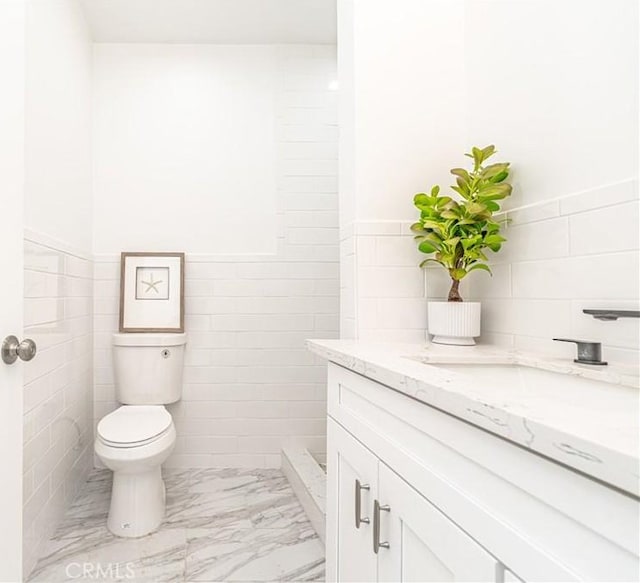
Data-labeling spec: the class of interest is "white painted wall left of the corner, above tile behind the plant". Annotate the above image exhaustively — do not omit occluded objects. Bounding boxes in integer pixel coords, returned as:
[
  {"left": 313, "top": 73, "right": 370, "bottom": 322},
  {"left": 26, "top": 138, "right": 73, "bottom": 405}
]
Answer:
[{"left": 347, "top": 0, "right": 466, "bottom": 220}]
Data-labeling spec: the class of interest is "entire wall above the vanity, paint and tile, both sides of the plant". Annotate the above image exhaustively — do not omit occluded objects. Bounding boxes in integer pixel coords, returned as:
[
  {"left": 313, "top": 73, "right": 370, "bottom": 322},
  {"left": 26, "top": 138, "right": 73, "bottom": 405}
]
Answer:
[{"left": 339, "top": 0, "right": 640, "bottom": 362}]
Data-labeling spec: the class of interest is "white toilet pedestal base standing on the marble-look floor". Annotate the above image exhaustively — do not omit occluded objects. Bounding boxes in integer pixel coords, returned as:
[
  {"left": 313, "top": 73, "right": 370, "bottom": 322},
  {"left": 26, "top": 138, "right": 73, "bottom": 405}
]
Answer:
[{"left": 107, "top": 466, "right": 166, "bottom": 538}]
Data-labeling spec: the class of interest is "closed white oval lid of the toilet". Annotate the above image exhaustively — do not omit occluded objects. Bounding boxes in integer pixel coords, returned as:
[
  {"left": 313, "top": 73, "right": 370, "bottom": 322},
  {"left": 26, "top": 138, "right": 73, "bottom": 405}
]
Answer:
[{"left": 98, "top": 405, "right": 172, "bottom": 444}]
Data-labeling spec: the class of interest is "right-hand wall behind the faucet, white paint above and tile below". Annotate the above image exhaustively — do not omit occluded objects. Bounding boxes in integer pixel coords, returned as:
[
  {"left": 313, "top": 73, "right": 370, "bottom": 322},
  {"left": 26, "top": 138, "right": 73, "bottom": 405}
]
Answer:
[{"left": 465, "top": 0, "right": 640, "bottom": 364}]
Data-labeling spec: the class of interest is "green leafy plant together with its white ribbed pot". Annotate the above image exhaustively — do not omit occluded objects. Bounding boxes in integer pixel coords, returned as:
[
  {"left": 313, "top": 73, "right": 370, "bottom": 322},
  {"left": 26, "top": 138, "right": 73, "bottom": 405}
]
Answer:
[{"left": 411, "top": 146, "right": 511, "bottom": 346}]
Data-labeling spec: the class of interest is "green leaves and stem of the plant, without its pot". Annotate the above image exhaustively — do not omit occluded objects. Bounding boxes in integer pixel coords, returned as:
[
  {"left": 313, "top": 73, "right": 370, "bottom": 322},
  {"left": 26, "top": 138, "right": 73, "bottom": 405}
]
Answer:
[{"left": 411, "top": 146, "right": 511, "bottom": 302}]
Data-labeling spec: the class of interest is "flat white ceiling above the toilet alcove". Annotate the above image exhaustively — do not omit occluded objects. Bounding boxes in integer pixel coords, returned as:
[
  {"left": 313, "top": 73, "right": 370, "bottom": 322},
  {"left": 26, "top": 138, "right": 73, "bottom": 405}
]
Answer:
[{"left": 82, "top": 0, "right": 336, "bottom": 44}]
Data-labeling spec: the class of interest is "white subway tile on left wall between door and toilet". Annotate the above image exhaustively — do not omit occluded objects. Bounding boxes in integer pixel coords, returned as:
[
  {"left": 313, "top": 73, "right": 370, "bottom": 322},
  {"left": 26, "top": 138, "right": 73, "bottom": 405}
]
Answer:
[{"left": 23, "top": 232, "right": 93, "bottom": 573}]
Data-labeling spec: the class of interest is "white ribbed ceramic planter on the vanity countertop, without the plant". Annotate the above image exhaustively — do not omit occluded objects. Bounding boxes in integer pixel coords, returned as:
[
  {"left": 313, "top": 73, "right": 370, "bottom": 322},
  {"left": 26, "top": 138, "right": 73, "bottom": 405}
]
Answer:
[{"left": 427, "top": 302, "right": 480, "bottom": 346}]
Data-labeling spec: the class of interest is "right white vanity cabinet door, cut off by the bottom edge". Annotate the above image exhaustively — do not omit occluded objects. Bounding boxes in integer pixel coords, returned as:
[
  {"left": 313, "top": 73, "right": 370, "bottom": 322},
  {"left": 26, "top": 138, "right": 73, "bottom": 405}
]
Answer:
[{"left": 372, "top": 462, "right": 499, "bottom": 583}]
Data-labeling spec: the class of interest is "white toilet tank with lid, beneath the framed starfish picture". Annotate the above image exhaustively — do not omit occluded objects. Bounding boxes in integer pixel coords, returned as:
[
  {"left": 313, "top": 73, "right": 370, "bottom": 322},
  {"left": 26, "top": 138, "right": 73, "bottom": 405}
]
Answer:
[{"left": 113, "top": 333, "right": 187, "bottom": 405}]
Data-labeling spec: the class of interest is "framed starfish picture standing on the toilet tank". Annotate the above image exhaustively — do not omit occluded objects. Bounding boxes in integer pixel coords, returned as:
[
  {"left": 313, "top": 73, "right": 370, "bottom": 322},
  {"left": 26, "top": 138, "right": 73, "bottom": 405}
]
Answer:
[{"left": 120, "top": 252, "right": 184, "bottom": 332}]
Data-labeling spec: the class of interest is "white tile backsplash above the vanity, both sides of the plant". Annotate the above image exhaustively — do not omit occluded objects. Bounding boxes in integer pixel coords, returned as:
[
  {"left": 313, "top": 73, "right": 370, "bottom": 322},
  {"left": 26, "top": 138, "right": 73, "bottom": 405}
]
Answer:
[{"left": 341, "top": 180, "right": 640, "bottom": 364}]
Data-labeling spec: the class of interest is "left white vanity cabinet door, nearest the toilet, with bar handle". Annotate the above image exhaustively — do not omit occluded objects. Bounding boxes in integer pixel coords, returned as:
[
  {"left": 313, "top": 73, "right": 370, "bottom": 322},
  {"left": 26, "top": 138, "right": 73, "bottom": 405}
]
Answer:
[{"left": 326, "top": 418, "right": 378, "bottom": 583}]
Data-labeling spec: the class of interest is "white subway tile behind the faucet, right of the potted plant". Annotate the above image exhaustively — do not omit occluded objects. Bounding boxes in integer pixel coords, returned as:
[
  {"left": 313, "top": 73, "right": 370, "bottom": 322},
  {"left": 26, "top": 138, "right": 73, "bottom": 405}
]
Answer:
[{"left": 488, "top": 180, "right": 640, "bottom": 365}]
